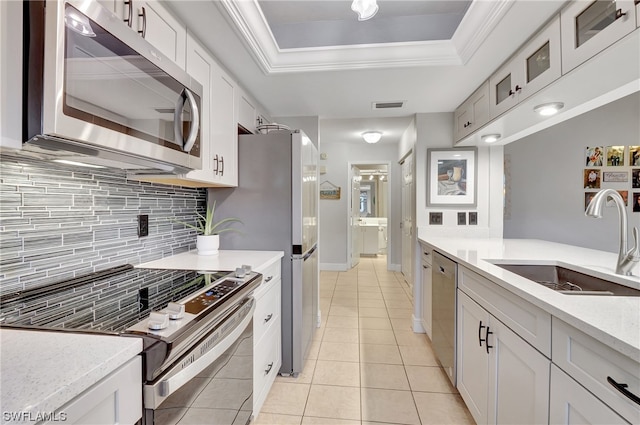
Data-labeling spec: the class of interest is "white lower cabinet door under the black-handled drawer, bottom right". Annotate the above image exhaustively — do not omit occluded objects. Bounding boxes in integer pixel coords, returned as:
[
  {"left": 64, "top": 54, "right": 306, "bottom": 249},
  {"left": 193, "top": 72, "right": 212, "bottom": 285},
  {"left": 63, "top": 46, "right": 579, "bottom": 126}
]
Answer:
[{"left": 549, "top": 365, "right": 628, "bottom": 425}]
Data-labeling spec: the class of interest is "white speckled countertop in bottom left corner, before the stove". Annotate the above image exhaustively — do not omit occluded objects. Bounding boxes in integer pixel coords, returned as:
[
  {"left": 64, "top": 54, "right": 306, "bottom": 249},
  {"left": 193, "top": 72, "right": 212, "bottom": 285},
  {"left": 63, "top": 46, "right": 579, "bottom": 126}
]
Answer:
[{"left": 0, "top": 328, "right": 142, "bottom": 424}]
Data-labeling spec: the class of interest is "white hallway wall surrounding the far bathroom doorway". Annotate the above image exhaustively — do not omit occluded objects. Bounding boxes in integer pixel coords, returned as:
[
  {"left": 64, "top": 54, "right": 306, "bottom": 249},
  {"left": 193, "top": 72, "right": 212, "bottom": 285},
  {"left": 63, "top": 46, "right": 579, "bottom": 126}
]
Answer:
[{"left": 320, "top": 140, "right": 401, "bottom": 270}]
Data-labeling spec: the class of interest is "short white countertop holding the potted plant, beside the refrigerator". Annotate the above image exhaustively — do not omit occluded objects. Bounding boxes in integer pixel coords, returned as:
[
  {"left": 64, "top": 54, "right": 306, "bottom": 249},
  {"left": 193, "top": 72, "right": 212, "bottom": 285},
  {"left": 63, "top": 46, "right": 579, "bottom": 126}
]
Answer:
[{"left": 136, "top": 249, "right": 284, "bottom": 271}]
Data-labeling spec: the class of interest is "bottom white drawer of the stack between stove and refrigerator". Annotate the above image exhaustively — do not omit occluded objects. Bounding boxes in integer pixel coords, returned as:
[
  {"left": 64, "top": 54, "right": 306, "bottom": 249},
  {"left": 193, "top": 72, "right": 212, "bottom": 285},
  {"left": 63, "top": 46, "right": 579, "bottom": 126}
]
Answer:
[{"left": 253, "top": 316, "right": 282, "bottom": 416}]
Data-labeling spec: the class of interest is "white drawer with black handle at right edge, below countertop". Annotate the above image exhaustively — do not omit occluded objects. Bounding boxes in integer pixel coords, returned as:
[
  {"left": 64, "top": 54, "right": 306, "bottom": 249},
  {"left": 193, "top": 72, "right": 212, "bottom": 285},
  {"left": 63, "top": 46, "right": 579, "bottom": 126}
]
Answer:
[{"left": 551, "top": 317, "right": 640, "bottom": 424}]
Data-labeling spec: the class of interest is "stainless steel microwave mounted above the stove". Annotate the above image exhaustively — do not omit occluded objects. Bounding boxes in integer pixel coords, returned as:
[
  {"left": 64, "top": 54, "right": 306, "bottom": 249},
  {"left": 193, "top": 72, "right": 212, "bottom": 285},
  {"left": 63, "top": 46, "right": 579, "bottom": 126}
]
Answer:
[{"left": 22, "top": 0, "right": 202, "bottom": 174}]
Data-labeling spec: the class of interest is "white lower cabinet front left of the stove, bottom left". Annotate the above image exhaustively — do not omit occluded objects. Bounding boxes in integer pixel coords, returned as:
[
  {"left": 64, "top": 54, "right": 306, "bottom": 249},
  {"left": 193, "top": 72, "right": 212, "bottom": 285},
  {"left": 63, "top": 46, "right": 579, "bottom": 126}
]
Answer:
[{"left": 47, "top": 356, "right": 142, "bottom": 424}]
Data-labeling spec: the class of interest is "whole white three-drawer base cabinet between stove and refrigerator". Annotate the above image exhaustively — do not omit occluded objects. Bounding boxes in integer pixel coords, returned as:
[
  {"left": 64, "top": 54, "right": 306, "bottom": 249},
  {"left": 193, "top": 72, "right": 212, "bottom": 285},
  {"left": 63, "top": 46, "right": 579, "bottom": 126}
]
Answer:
[{"left": 253, "top": 259, "right": 282, "bottom": 417}]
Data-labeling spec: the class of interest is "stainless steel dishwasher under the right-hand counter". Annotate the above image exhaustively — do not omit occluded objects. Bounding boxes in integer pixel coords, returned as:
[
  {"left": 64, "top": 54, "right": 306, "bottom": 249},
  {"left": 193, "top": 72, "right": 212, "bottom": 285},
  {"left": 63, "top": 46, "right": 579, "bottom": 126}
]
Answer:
[{"left": 431, "top": 251, "right": 458, "bottom": 386}]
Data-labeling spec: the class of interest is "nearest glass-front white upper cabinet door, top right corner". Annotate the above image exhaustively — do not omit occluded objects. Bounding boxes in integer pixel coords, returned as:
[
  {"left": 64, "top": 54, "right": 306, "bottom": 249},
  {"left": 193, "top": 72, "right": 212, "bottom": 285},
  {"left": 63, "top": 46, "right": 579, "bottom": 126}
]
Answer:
[{"left": 560, "top": 0, "right": 637, "bottom": 73}]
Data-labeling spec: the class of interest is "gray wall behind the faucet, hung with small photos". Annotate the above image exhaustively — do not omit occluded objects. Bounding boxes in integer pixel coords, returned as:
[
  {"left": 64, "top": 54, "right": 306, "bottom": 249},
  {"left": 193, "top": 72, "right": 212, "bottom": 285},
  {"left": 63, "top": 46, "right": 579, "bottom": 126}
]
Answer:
[{"left": 504, "top": 93, "right": 640, "bottom": 252}]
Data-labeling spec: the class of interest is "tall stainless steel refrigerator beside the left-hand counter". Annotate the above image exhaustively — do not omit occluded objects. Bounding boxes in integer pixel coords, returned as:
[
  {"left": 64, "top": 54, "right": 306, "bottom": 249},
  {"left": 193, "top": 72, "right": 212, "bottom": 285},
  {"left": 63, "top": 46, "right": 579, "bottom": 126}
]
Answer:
[{"left": 209, "top": 130, "right": 318, "bottom": 376}]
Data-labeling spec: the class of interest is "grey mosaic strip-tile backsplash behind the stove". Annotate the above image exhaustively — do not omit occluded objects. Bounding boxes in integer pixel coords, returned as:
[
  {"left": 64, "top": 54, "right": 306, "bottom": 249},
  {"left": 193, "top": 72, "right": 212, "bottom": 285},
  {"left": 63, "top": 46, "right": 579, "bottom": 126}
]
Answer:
[{"left": 0, "top": 155, "right": 206, "bottom": 294}]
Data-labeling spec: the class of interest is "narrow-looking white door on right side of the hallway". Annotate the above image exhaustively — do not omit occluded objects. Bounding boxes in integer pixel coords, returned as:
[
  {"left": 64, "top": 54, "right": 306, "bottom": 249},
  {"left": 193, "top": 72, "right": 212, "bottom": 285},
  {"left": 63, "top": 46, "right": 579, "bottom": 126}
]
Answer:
[{"left": 401, "top": 153, "right": 414, "bottom": 288}]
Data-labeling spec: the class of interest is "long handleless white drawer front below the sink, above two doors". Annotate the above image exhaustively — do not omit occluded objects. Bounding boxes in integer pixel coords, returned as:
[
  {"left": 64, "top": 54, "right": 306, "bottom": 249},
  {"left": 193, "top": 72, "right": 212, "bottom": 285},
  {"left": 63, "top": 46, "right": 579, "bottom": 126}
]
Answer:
[{"left": 458, "top": 267, "right": 551, "bottom": 358}]
